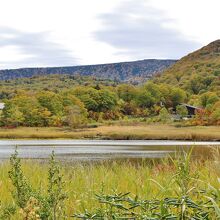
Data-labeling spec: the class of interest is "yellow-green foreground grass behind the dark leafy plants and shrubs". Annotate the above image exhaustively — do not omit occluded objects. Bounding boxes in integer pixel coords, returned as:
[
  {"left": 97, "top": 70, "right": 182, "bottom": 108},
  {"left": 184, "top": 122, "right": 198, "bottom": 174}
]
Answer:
[{"left": 0, "top": 149, "right": 220, "bottom": 220}]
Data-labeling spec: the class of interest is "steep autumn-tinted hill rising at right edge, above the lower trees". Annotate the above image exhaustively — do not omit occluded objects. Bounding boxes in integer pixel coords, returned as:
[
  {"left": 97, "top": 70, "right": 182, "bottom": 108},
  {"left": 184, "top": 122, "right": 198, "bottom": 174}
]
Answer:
[{"left": 154, "top": 40, "right": 220, "bottom": 95}]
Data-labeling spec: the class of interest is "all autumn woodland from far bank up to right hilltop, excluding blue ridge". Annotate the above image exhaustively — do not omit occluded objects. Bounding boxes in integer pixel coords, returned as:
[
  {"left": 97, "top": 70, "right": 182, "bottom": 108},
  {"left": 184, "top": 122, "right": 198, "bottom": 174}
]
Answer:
[{"left": 0, "top": 40, "right": 220, "bottom": 128}]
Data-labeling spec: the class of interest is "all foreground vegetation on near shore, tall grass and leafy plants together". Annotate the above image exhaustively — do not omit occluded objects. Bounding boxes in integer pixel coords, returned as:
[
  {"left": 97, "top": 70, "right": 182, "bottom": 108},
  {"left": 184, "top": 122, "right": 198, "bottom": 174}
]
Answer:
[{"left": 0, "top": 148, "right": 220, "bottom": 220}]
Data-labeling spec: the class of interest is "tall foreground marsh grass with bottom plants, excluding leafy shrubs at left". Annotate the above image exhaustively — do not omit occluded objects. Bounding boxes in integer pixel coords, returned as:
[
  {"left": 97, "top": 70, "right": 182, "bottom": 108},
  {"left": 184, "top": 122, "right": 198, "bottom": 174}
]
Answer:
[{"left": 0, "top": 148, "right": 220, "bottom": 220}]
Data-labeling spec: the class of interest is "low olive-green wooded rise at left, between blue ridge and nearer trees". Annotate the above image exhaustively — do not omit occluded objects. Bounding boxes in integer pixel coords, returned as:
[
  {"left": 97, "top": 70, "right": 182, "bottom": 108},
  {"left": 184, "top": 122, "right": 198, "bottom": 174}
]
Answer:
[{"left": 0, "top": 74, "right": 119, "bottom": 97}]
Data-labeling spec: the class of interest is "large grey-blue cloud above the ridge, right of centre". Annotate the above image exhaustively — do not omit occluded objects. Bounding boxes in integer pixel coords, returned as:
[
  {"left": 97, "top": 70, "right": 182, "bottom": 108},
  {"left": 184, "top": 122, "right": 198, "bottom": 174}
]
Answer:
[{"left": 95, "top": 0, "right": 200, "bottom": 59}]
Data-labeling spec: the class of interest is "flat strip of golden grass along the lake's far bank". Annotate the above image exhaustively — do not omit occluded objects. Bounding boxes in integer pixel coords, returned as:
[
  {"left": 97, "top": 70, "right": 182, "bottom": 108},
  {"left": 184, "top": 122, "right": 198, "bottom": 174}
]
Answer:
[{"left": 0, "top": 124, "right": 220, "bottom": 140}]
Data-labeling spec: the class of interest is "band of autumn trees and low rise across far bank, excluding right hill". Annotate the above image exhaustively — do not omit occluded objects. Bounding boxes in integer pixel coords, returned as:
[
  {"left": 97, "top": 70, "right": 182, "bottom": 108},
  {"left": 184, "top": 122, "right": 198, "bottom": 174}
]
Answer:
[{"left": 0, "top": 75, "right": 220, "bottom": 128}]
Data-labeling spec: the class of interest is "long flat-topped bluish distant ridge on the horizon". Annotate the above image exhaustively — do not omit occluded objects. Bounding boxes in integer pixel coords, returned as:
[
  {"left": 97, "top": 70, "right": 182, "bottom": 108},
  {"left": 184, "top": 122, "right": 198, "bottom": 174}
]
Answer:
[{"left": 0, "top": 59, "right": 176, "bottom": 83}]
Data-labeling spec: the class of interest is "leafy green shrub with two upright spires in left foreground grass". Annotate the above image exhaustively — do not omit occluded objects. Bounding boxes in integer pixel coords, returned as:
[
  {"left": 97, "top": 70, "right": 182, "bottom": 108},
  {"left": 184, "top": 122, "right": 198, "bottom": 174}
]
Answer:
[{"left": 9, "top": 151, "right": 66, "bottom": 220}]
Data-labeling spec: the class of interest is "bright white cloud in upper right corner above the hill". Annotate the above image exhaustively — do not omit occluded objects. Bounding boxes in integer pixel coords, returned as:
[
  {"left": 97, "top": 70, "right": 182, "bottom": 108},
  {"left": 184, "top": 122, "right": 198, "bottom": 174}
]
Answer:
[{"left": 149, "top": 0, "right": 220, "bottom": 44}]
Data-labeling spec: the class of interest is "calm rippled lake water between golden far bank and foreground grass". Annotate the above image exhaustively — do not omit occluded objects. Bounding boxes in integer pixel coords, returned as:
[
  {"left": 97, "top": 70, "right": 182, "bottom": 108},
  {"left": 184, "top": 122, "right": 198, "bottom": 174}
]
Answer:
[{"left": 0, "top": 140, "right": 220, "bottom": 161}]
